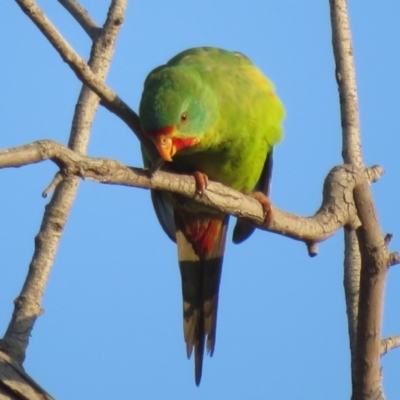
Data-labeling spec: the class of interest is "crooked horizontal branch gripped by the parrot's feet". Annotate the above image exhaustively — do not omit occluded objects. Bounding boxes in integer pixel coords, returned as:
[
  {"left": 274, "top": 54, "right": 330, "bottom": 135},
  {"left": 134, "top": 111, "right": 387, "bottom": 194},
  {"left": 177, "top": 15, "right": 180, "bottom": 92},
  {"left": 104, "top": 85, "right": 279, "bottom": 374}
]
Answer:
[{"left": 0, "top": 140, "right": 383, "bottom": 243}]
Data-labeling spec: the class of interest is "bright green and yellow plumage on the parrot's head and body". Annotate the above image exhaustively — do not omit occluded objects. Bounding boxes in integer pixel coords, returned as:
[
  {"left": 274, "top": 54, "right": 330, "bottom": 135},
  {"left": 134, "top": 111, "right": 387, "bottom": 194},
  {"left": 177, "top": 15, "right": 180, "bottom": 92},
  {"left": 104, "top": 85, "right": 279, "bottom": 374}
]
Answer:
[{"left": 140, "top": 48, "right": 284, "bottom": 193}]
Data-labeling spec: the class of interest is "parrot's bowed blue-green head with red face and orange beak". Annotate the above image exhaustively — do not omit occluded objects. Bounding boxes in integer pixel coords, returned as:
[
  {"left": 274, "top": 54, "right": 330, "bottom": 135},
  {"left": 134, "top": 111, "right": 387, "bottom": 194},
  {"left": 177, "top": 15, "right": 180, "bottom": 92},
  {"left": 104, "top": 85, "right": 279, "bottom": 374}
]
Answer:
[{"left": 139, "top": 66, "right": 218, "bottom": 161}]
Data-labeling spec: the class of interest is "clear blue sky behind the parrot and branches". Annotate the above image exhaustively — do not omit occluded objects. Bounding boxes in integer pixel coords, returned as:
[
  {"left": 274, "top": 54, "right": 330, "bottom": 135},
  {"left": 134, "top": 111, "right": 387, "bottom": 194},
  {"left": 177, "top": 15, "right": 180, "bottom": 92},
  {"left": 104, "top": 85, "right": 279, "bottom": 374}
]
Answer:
[{"left": 0, "top": 0, "right": 400, "bottom": 400}]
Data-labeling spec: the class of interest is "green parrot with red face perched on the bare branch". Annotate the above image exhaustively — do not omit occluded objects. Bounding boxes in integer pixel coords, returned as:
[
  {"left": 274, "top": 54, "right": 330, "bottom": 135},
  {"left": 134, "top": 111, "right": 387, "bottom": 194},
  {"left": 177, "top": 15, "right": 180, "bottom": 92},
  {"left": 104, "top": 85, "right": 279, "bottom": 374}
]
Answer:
[{"left": 139, "top": 47, "right": 284, "bottom": 386}]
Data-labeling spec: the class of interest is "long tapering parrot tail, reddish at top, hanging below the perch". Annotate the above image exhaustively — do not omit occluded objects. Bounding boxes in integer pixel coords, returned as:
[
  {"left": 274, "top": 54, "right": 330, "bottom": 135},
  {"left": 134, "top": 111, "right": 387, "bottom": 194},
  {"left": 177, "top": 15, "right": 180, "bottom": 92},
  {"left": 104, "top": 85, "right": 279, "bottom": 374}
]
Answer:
[{"left": 175, "top": 211, "right": 228, "bottom": 386}]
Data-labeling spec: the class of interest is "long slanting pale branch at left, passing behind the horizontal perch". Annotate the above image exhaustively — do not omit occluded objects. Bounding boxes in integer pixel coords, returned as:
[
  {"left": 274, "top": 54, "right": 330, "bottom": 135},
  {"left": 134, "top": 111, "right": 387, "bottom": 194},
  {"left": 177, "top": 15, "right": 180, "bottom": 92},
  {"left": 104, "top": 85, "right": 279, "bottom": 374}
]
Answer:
[{"left": 1, "top": 0, "right": 126, "bottom": 363}]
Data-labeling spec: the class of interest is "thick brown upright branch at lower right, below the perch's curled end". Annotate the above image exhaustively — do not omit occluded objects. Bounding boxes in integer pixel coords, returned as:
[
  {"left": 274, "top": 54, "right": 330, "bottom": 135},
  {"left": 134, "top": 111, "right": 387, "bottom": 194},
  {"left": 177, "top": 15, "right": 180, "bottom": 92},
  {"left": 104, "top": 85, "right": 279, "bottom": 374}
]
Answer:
[{"left": 352, "top": 180, "right": 389, "bottom": 400}]
